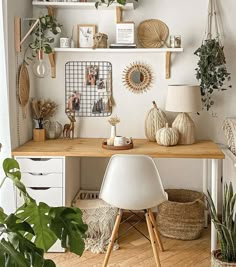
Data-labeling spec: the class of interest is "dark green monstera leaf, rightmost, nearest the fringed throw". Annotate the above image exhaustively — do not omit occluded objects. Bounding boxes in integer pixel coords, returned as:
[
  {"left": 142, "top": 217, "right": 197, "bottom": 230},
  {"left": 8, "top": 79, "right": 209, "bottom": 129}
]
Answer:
[{"left": 50, "top": 207, "right": 88, "bottom": 256}]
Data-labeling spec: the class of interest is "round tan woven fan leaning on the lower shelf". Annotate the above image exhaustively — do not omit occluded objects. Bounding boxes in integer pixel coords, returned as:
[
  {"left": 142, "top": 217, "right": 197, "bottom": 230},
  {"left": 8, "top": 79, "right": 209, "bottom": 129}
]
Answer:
[{"left": 138, "top": 19, "right": 169, "bottom": 48}]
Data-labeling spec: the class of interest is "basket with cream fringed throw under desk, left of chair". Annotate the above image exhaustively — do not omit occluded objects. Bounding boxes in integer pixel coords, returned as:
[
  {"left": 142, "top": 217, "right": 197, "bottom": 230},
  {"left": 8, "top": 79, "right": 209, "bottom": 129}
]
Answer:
[{"left": 72, "top": 190, "right": 118, "bottom": 253}]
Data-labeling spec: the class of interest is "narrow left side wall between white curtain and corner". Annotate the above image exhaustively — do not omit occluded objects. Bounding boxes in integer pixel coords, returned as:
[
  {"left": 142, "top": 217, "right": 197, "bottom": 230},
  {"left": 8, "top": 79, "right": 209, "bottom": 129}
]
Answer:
[{"left": 6, "top": 0, "right": 34, "bottom": 149}]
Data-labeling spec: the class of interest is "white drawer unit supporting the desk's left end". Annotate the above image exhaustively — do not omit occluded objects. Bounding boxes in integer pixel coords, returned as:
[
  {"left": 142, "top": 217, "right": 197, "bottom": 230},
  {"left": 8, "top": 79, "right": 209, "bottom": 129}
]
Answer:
[{"left": 15, "top": 155, "right": 80, "bottom": 252}]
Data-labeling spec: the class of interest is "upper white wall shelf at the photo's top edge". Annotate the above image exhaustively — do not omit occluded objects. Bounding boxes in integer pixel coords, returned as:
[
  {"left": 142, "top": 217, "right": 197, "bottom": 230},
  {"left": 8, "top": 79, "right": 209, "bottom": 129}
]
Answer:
[{"left": 32, "top": 1, "right": 134, "bottom": 10}]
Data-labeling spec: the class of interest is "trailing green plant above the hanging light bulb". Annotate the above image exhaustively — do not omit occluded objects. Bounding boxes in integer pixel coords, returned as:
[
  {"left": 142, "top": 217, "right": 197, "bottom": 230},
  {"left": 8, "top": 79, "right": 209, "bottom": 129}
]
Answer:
[{"left": 29, "top": 15, "right": 62, "bottom": 57}]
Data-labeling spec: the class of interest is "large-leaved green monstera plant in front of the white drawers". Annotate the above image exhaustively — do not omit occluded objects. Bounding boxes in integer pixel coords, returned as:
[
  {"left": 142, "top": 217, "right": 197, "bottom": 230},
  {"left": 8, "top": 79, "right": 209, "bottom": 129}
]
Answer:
[{"left": 0, "top": 158, "right": 87, "bottom": 267}]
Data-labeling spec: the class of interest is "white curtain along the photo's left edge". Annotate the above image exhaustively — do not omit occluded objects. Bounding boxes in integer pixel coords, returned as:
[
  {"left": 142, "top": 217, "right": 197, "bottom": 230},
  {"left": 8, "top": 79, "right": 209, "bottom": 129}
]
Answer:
[{"left": 0, "top": 0, "right": 15, "bottom": 213}]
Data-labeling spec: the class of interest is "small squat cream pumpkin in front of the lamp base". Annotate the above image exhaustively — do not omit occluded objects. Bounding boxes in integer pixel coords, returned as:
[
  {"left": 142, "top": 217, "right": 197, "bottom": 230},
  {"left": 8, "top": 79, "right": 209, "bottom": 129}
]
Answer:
[{"left": 156, "top": 123, "right": 179, "bottom": 146}]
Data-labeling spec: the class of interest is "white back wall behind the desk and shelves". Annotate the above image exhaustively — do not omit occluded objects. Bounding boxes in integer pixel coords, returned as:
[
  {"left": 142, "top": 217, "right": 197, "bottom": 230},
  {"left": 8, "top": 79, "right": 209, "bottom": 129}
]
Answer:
[{"left": 29, "top": 0, "right": 236, "bottom": 193}]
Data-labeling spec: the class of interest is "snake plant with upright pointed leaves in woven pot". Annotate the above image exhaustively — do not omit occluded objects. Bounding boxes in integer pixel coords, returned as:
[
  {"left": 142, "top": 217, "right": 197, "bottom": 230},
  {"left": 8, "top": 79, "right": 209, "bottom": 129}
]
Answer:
[{"left": 207, "top": 183, "right": 236, "bottom": 267}]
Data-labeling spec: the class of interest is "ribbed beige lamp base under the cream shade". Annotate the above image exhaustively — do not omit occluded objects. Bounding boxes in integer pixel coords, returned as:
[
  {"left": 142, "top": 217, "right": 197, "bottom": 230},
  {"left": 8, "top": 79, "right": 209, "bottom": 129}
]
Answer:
[{"left": 172, "top": 113, "right": 195, "bottom": 145}]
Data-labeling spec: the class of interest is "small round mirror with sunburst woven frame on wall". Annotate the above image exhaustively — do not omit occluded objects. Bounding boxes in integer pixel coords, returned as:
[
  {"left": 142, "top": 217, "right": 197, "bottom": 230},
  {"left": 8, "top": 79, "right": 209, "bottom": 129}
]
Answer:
[{"left": 123, "top": 62, "right": 153, "bottom": 94}]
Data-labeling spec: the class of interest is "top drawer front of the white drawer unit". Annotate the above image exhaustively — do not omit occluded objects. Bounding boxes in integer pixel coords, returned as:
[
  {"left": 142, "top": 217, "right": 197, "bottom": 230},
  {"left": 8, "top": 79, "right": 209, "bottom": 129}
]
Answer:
[{"left": 16, "top": 157, "right": 63, "bottom": 174}]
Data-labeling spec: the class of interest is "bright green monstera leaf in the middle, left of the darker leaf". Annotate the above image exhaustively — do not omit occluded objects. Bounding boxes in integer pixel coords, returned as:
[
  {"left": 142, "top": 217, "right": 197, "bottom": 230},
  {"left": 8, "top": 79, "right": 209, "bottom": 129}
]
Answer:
[{"left": 16, "top": 202, "right": 57, "bottom": 251}]
